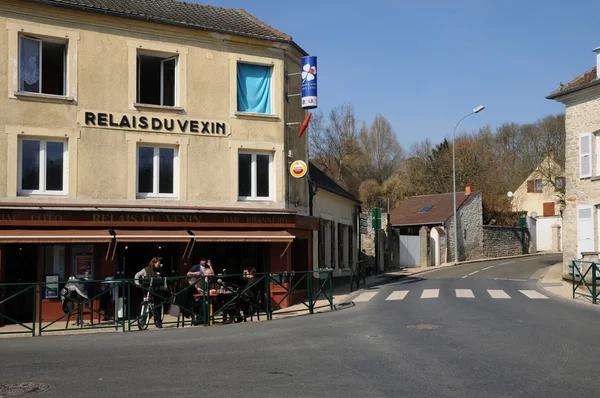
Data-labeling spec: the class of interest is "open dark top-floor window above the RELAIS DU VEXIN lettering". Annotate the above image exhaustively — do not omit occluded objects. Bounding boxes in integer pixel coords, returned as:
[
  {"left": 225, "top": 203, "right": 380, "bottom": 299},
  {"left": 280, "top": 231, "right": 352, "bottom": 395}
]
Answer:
[{"left": 136, "top": 51, "right": 178, "bottom": 106}]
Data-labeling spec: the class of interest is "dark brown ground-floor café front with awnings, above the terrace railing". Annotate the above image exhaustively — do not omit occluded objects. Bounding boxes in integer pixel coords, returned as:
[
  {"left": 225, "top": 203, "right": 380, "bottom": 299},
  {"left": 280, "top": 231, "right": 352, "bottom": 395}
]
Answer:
[{"left": 0, "top": 204, "right": 318, "bottom": 318}]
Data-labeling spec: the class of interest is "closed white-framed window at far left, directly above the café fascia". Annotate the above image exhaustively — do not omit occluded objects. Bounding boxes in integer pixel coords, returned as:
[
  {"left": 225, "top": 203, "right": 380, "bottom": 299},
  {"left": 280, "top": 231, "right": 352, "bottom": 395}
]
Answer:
[{"left": 18, "top": 139, "right": 69, "bottom": 195}]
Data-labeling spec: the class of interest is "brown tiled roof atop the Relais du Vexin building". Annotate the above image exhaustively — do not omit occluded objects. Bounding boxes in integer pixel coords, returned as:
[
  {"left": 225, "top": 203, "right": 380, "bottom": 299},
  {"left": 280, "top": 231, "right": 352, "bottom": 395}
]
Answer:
[{"left": 27, "top": 0, "right": 293, "bottom": 43}]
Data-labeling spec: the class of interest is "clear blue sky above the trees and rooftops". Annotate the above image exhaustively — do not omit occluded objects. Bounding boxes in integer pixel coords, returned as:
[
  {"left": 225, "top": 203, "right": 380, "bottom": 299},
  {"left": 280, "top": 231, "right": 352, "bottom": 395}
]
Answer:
[{"left": 198, "top": 0, "right": 600, "bottom": 149}]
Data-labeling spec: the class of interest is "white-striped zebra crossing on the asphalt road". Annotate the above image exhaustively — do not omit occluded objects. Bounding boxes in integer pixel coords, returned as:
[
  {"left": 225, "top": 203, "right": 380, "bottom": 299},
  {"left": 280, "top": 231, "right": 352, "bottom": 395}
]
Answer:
[{"left": 352, "top": 289, "right": 548, "bottom": 303}]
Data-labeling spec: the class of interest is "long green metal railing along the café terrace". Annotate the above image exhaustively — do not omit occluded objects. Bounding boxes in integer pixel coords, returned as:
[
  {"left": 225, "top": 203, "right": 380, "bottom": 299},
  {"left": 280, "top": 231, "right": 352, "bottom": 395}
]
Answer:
[{"left": 0, "top": 269, "right": 334, "bottom": 336}]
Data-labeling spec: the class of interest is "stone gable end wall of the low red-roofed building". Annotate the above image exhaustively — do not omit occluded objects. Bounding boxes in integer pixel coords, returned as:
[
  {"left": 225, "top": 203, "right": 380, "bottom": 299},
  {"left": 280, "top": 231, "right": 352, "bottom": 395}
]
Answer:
[{"left": 446, "top": 194, "right": 484, "bottom": 262}]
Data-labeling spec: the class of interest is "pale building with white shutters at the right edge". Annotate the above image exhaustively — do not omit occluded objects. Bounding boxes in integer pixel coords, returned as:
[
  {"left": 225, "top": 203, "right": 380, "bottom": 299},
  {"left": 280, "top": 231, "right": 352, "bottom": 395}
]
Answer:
[{"left": 547, "top": 48, "right": 600, "bottom": 275}]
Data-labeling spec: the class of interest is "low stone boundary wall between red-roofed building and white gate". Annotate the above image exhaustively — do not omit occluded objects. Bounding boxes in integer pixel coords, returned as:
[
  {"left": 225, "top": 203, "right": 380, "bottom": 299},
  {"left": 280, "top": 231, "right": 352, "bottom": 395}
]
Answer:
[{"left": 483, "top": 225, "right": 529, "bottom": 258}]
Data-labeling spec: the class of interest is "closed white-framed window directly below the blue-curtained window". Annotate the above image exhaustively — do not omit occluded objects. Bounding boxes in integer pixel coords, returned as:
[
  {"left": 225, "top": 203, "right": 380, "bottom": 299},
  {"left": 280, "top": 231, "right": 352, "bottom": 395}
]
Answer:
[{"left": 238, "top": 152, "right": 273, "bottom": 200}]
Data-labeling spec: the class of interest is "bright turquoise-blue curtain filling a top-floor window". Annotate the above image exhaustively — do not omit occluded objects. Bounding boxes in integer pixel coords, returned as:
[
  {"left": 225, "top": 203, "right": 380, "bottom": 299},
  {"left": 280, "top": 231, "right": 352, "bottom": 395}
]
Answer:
[{"left": 237, "top": 63, "right": 271, "bottom": 114}]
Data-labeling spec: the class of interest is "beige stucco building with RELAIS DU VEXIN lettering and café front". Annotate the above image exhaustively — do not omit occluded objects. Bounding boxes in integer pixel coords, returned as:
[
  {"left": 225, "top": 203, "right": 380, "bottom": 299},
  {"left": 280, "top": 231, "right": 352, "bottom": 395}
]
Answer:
[{"left": 0, "top": 0, "right": 318, "bottom": 320}]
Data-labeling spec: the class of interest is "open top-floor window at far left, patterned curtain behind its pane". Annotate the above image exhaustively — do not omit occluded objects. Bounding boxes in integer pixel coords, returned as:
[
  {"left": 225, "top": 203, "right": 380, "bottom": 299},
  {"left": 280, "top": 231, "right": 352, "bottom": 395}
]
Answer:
[{"left": 19, "top": 35, "right": 67, "bottom": 96}]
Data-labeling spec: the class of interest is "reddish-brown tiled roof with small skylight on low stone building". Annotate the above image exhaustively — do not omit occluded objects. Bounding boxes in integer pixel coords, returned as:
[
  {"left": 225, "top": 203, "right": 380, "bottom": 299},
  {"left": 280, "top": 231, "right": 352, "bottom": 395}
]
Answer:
[{"left": 390, "top": 192, "right": 479, "bottom": 226}]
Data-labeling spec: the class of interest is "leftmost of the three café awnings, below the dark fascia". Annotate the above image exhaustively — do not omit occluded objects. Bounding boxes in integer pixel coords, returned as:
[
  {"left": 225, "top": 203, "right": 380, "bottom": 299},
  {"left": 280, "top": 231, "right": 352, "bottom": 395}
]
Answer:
[{"left": 0, "top": 229, "right": 113, "bottom": 243}]
